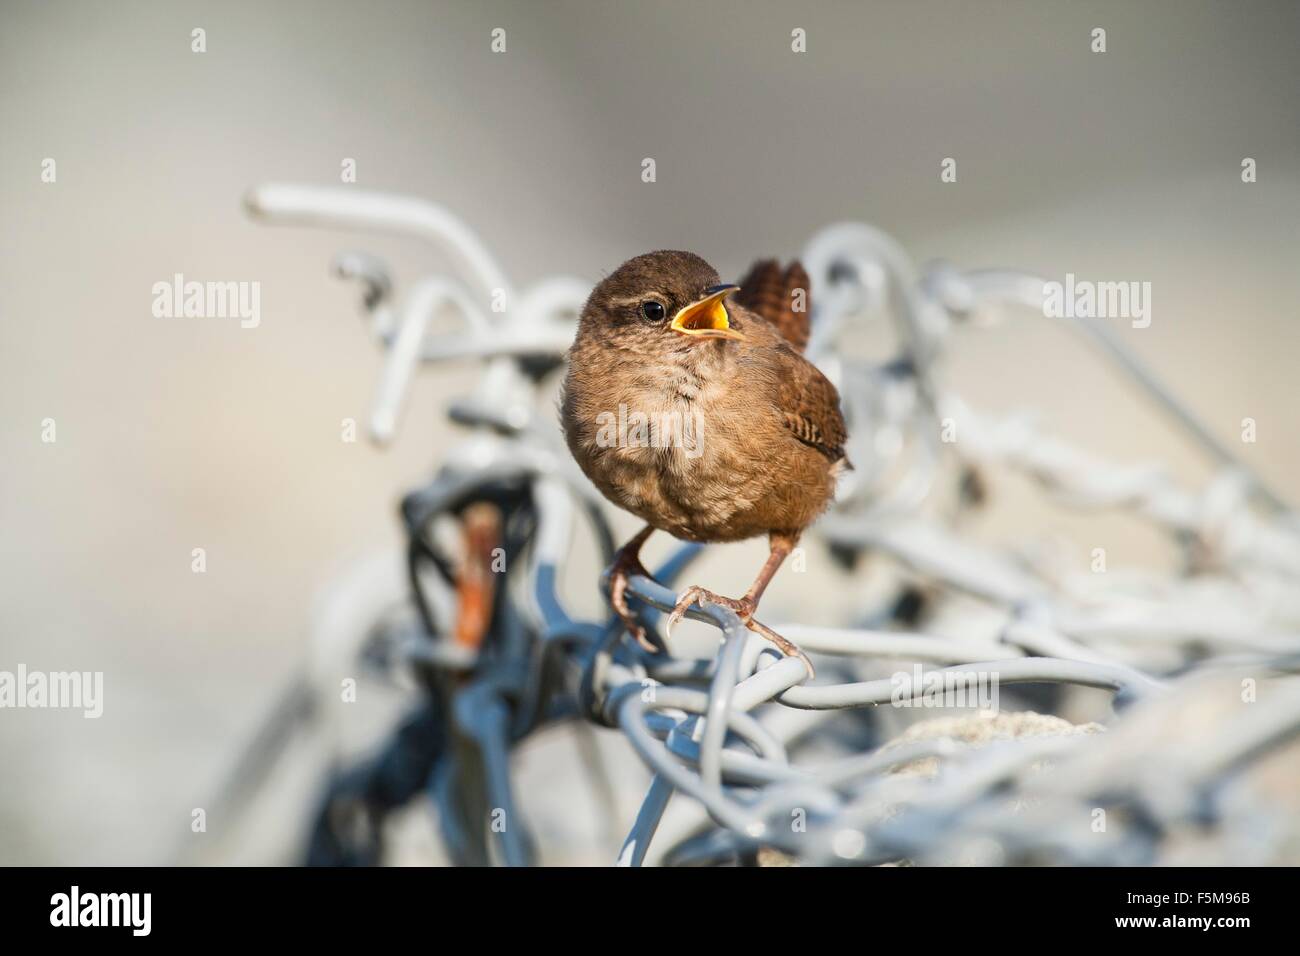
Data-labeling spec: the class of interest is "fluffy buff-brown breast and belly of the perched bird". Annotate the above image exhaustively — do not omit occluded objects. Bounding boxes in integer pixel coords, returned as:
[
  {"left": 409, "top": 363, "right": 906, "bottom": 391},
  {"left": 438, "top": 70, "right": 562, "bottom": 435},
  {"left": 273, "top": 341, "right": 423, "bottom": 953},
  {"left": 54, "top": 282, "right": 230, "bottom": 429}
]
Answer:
[{"left": 563, "top": 342, "right": 835, "bottom": 541}]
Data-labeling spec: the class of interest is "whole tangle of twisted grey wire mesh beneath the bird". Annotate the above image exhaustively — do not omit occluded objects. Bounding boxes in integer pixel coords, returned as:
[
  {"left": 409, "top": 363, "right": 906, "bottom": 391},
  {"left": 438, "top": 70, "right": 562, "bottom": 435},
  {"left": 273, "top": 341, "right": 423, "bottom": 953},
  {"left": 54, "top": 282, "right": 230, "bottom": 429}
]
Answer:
[{"left": 218, "top": 186, "right": 1300, "bottom": 865}]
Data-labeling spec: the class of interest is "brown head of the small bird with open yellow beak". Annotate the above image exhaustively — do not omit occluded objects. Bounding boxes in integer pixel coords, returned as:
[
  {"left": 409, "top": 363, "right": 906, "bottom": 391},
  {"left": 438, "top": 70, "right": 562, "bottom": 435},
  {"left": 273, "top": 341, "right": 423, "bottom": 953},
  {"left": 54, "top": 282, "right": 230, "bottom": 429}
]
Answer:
[{"left": 582, "top": 251, "right": 744, "bottom": 351}]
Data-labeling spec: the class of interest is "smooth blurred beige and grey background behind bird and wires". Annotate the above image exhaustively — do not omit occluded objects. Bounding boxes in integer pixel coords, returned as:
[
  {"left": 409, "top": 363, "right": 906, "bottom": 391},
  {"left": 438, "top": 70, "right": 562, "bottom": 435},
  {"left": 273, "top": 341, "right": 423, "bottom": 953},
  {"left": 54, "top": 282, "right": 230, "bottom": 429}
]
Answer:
[{"left": 0, "top": 0, "right": 1300, "bottom": 864}]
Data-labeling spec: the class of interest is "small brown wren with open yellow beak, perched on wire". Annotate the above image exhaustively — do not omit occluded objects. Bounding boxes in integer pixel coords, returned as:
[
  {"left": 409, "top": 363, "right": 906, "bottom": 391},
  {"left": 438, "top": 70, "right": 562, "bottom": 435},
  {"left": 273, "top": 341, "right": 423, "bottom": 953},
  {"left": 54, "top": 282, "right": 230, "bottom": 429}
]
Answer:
[{"left": 562, "top": 251, "right": 849, "bottom": 669}]
